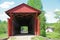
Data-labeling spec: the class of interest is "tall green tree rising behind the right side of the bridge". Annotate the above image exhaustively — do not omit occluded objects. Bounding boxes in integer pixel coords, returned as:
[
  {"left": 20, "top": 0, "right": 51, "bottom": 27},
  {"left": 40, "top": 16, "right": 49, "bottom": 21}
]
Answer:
[{"left": 27, "top": 0, "right": 46, "bottom": 37}]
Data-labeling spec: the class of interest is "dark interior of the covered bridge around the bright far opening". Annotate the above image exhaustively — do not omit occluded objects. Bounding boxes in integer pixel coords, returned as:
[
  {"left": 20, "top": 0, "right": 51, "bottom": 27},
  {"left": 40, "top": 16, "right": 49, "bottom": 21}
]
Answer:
[{"left": 13, "top": 15, "right": 34, "bottom": 35}]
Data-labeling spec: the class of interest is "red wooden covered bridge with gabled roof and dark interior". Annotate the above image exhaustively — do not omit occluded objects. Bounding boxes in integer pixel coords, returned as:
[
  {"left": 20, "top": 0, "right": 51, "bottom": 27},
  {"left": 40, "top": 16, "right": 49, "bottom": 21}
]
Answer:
[{"left": 6, "top": 3, "right": 41, "bottom": 36}]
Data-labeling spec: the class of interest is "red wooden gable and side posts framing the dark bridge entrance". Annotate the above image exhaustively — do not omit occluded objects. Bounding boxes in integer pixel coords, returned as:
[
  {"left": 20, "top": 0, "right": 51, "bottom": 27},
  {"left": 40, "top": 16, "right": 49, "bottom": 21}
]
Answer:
[{"left": 6, "top": 3, "right": 41, "bottom": 36}]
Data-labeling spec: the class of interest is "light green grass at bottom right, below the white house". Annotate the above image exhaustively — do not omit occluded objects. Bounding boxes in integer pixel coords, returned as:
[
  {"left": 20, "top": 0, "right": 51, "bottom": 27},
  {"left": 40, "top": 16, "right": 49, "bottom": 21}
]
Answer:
[{"left": 32, "top": 32, "right": 60, "bottom": 40}]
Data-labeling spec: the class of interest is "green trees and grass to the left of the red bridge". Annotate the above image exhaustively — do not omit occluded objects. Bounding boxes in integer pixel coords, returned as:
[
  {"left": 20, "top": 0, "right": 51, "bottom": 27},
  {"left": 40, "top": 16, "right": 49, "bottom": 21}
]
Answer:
[{"left": 0, "top": 20, "right": 7, "bottom": 38}]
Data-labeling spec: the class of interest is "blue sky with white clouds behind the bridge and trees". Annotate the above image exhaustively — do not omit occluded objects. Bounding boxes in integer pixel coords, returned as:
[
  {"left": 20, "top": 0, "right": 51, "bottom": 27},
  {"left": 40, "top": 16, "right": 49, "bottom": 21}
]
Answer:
[{"left": 0, "top": 0, "right": 60, "bottom": 23}]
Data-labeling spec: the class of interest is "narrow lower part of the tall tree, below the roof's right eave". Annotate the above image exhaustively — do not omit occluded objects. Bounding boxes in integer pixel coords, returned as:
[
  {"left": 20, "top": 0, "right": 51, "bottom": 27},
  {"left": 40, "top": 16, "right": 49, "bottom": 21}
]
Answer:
[{"left": 40, "top": 12, "right": 46, "bottom": 37}]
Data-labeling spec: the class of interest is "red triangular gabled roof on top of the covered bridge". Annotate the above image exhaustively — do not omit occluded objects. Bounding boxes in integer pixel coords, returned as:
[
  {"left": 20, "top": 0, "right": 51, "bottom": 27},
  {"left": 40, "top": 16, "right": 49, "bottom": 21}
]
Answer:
[{"left": 6, "top": 3, "right": 40, "bottom": 15}]
